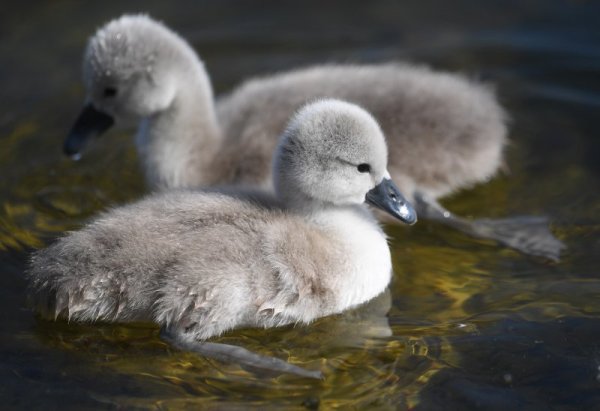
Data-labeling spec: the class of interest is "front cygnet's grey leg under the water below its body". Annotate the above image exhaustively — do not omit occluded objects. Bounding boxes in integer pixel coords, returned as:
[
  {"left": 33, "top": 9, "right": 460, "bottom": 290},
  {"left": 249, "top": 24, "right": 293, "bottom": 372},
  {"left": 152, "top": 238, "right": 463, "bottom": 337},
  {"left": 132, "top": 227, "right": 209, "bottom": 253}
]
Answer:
[{"left": 160, "top": 327, "right": 323, "bottom": 379}]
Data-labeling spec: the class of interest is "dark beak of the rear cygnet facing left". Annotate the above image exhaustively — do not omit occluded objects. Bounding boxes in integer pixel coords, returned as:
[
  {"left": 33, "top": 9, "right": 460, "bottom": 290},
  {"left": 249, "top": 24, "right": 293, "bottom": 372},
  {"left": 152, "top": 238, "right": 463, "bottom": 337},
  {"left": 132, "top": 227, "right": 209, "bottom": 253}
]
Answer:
[{"left": 63, "top": 104, "right": 115, "bottom": 157}]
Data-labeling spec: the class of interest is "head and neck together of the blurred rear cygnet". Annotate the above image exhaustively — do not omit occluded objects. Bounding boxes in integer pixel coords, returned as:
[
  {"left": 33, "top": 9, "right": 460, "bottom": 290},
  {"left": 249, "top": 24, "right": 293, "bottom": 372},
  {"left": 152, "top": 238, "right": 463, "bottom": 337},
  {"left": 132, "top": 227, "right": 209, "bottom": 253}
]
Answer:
[{"left": 64, "top": 15, "right": 220, "bottom": 188}]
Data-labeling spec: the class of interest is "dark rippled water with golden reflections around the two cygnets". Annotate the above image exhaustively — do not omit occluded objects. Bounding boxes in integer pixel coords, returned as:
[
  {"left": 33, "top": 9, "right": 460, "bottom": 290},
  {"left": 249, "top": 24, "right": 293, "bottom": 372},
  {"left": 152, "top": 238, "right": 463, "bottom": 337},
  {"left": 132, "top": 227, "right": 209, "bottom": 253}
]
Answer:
[{"left": 0, "top": 0, "right": 600, "bottom": 410}]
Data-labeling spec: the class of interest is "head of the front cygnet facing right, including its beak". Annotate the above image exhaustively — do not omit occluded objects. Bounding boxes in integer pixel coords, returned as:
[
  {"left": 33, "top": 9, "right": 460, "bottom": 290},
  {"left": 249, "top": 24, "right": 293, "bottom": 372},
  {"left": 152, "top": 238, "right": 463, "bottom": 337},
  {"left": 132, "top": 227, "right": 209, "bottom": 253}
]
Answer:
[{"left": 273, "top": 100, "right": 417, "bottom": 224}]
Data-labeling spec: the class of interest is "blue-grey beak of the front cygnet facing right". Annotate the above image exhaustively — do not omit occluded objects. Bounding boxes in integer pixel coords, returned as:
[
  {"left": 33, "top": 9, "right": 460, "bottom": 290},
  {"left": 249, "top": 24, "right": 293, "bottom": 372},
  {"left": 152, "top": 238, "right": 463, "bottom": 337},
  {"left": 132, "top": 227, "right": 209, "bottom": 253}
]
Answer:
[{"left": 366, "top": 178, "right": 417, "bottom": 225}]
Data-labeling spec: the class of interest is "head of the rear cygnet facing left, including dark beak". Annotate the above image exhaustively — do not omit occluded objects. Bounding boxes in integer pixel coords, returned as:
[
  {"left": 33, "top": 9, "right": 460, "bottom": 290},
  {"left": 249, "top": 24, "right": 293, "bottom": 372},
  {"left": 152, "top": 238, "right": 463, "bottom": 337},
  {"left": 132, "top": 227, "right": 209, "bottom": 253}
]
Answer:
[{"left": 64, "top": 15, "right": 193, "bottom": 155}]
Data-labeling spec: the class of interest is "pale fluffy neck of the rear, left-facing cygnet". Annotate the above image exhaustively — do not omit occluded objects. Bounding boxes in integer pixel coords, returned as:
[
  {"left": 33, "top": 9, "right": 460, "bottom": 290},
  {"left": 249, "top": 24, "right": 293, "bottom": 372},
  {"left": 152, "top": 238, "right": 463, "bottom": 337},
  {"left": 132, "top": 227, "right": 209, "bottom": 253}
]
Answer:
[{"left": 136, "top": 58, "right": 222, "bottom": 188}]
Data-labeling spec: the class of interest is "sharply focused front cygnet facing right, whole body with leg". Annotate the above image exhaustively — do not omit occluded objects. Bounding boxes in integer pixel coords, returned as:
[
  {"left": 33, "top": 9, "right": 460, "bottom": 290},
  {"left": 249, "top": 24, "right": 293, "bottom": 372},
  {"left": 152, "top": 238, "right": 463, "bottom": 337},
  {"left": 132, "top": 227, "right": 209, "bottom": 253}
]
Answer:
[{"left": 28, "top": 100, "right": 416, "bottom": 376}]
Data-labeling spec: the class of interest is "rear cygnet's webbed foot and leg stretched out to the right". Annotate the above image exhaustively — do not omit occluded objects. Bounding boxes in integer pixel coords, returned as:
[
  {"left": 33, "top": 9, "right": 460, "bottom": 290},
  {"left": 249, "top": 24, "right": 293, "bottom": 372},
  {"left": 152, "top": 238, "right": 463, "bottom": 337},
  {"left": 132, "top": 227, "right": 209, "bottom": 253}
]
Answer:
[{"left": 414, "top": 192, "right": 566, "bottom": 261}]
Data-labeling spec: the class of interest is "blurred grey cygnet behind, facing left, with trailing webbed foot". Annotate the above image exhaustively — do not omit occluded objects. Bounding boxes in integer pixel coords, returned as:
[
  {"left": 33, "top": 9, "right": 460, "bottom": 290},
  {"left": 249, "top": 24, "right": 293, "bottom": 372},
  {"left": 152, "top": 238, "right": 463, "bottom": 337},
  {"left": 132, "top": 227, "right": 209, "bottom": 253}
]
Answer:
[{"left": 65, "top": 15, "right": 563, "bottom": 259}]
